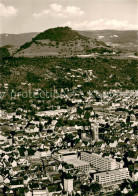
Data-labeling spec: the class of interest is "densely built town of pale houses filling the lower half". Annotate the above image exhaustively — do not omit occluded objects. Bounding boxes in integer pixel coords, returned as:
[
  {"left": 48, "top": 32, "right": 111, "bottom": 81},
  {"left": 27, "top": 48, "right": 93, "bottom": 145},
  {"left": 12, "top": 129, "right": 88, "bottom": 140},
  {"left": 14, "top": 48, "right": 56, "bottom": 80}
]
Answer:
[{"left": 0, "top": 87, "right": 138, "bottom": 196}]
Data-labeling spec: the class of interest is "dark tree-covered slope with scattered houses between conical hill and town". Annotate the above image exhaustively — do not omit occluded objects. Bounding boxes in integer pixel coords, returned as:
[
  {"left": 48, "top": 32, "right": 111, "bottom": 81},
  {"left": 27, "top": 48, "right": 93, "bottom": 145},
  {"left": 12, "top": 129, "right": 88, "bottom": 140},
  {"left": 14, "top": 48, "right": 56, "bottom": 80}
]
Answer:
[{"left": 0, "top": 57, "right": 138, "bottom": 112}]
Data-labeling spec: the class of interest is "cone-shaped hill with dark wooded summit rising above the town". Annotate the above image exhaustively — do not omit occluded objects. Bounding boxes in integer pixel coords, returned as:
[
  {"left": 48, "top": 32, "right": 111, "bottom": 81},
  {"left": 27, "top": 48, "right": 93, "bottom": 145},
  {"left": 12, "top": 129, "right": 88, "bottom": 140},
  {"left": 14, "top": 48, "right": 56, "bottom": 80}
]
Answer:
[{"left": 15, "top": 27, "right": 110, "bottom": 57}]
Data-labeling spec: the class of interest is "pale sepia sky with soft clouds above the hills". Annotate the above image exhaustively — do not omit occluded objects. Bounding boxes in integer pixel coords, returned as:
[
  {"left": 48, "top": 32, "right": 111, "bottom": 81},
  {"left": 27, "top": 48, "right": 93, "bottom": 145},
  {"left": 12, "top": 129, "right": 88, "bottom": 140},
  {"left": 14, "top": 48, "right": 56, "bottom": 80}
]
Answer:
[{"left": 0, "top": 0, "right": 138, "bottom": 34}]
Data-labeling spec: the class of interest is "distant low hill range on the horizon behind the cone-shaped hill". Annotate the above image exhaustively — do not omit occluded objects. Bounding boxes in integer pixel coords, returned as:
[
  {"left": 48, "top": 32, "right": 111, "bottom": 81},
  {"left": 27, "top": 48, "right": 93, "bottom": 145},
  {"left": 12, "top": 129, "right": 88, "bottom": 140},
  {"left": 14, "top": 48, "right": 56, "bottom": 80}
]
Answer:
[{"left": 0, "top": 30, "right": 138, "bottom": 47}]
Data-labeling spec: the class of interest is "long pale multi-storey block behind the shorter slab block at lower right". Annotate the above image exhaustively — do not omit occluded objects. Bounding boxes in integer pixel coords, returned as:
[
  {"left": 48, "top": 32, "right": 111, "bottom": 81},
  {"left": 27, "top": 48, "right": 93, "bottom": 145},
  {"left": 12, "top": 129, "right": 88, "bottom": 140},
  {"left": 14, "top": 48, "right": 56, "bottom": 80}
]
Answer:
[{"left": 81, "top": 152, "right": 122, "bottom": 171}]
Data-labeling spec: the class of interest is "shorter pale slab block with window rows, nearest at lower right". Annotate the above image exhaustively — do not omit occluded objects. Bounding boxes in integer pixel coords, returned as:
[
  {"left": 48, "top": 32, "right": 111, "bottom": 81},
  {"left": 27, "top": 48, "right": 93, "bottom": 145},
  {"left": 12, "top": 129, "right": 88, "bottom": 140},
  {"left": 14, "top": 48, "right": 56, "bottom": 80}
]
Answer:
[{"left": 94, "top": 168, "right": 129, "bottom": 186}]
